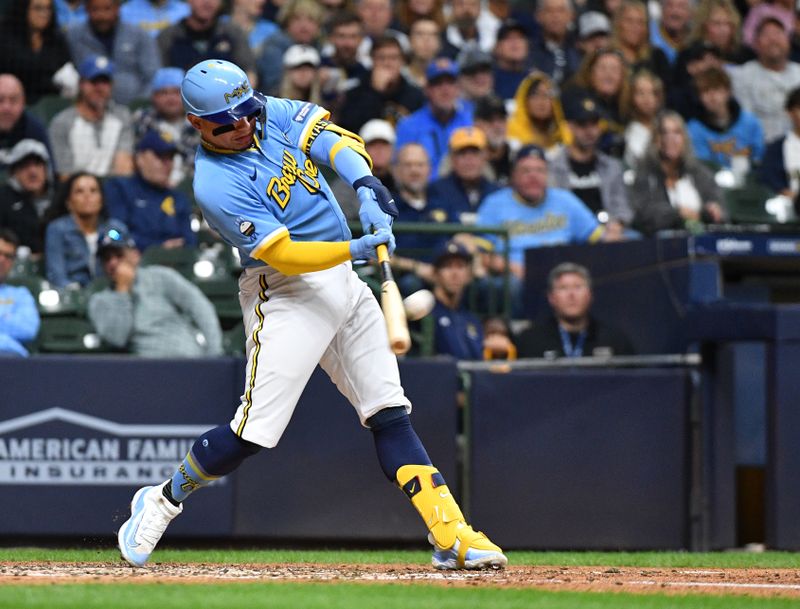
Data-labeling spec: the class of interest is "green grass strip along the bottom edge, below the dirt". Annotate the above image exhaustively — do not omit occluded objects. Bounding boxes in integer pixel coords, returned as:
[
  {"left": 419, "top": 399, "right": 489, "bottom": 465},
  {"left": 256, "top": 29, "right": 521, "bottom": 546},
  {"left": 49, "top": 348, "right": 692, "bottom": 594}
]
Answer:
[{"left": 0, "top": 583, "right": 798, "bottom": 609}]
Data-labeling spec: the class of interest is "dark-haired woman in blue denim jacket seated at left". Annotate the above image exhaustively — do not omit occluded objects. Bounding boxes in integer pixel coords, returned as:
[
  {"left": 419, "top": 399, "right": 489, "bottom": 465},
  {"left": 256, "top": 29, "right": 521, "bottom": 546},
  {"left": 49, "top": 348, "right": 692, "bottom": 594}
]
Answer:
[{"left": 44, "top": 172, "right": 127, "bottom": 288}]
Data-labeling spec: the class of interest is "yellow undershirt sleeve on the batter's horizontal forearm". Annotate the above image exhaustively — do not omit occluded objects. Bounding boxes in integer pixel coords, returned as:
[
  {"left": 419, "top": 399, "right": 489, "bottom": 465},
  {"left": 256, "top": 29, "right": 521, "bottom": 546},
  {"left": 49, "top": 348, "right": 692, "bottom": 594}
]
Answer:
[{"left": 256, "top": 234, "right": 350, "bottom": 275}]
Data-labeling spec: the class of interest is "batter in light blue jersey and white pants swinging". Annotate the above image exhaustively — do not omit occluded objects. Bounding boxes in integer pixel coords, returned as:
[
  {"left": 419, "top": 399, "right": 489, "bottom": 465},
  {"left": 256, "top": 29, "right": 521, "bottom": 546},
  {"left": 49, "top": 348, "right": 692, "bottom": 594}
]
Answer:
[{"left": 118, "top": 60, "right": 508, "bottom": 569}]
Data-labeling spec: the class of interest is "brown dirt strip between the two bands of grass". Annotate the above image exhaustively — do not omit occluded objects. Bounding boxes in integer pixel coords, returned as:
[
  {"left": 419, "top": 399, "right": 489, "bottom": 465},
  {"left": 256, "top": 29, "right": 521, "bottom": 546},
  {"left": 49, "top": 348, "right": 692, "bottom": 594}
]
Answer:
[{"left": 0, "top": 562, "right": 800, "bottom": 598}]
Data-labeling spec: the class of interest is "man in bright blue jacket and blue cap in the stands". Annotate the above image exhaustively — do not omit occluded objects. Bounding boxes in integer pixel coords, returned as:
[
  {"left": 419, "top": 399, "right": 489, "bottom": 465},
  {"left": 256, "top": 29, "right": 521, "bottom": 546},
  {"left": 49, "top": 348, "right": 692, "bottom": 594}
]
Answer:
[{"left": 397, "top": 57, "right": 472, "bottom": 178}]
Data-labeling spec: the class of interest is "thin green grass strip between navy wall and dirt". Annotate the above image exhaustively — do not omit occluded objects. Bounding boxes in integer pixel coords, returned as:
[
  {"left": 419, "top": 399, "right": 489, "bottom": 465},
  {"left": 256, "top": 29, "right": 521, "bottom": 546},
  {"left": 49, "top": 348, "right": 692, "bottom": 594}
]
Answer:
[{"left": 0, "top": 548, "right": 800, "bottom": 569}]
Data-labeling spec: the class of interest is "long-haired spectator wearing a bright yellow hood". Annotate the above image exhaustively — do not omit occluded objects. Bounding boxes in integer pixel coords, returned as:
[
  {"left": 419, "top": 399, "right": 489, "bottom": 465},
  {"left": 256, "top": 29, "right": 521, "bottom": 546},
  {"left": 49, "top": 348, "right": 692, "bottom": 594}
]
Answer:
[{"left": 507, "top": 71, "right": 572, "bottom": 150}]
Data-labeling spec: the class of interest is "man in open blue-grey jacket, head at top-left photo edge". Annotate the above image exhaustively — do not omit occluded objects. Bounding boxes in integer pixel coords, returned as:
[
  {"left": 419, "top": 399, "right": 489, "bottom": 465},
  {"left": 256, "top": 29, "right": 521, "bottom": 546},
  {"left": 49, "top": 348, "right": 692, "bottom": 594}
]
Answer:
[{"left": 67, "top": 0, "right": 161, "bottom": 105}]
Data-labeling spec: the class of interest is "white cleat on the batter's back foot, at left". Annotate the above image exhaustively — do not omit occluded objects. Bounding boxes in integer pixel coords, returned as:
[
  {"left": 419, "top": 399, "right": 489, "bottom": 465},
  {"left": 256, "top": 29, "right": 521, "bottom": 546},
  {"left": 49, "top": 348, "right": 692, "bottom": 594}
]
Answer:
[{"left": 117, "top": 480, "right": 183, "bottom": 567}]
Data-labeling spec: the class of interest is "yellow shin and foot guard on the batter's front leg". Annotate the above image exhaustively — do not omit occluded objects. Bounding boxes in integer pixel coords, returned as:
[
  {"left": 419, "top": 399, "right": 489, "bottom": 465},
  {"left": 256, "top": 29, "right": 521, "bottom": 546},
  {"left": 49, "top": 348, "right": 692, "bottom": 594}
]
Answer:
[{"left": 397, "top": 465, "right": 501, "bottom": 567}]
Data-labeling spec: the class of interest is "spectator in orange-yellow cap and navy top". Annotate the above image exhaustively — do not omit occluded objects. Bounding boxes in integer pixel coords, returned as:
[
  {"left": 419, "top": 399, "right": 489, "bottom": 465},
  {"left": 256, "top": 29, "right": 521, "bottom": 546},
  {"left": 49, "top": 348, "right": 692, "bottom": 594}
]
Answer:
[{"left": 428, "top": 127, "right": 497, "bottom": 224}]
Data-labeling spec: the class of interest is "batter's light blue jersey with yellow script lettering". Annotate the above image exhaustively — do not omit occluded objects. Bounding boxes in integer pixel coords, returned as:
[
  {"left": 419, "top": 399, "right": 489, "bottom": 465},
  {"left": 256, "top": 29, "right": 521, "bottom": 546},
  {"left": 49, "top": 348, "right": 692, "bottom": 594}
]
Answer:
[{"left": 194, "top": 97, "right": 351, "bottom": 267}]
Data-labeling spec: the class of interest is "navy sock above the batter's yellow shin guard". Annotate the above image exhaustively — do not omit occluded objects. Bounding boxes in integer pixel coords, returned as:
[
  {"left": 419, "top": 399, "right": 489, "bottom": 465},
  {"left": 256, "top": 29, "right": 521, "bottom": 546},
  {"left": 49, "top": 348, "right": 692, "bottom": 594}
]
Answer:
[{"left": 367, "top": 406, "right": 431, "bottom": 482}]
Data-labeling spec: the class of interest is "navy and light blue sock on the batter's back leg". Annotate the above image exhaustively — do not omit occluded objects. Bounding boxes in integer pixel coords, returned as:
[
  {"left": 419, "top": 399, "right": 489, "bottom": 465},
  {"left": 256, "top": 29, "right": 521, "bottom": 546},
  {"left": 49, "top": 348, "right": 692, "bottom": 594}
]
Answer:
[{"left": 164, "top": 424, "right": 261, "bottom": 505}]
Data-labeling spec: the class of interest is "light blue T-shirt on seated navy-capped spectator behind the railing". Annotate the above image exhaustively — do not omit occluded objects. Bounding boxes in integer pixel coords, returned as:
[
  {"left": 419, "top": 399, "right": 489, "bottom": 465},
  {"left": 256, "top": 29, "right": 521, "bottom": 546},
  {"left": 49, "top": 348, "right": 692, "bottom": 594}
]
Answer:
[{"left": 478, "top": 187, "right": 603, "bottom": 264}]
